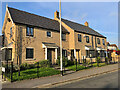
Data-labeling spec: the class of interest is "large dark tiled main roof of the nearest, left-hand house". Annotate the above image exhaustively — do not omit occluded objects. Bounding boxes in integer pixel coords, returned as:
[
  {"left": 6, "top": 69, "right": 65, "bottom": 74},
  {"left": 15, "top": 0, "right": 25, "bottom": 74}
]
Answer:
[{"left": 8, "top": 7, "right": 69, "bottom": 33}]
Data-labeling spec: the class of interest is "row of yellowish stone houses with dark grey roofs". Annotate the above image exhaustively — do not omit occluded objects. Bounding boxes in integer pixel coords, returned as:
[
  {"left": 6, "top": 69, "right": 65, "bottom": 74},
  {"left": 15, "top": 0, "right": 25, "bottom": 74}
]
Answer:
[{"left": 2, "top": 7, "right": 107, "bottom": 64}]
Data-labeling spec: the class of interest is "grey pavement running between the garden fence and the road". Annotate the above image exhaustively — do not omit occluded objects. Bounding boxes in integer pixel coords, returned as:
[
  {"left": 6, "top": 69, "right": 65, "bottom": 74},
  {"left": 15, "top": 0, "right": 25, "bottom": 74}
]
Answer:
[{"left": 2, "top": 64, "right": 118, "bottom": 88}]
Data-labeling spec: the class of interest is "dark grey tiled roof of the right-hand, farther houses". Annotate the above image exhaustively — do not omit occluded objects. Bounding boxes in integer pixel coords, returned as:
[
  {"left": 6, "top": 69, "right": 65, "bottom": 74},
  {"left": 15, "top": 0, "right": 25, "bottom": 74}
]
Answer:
[{"left": 62, "top": 19, "right": 106, "bottom": 38}]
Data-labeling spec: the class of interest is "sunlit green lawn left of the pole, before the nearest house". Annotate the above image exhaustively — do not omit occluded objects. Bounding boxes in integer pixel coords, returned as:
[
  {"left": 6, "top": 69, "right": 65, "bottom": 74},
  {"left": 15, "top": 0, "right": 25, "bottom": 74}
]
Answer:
[{"left": 5, "top": 67, "right": 60, "bottom": 81}]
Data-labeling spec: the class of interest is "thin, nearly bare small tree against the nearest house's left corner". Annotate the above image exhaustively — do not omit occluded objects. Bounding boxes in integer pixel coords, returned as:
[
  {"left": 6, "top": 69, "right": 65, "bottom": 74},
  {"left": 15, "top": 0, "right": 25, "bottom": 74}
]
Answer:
[{"left": 3, "top": 25, "right": 35, "bottom": 76}]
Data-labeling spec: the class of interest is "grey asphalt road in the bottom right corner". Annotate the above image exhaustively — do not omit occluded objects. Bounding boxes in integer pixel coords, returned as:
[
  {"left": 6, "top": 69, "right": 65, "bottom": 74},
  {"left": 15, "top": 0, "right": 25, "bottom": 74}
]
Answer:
[{"left": 53, "top": 71, "right": 118, "bottom": 88}]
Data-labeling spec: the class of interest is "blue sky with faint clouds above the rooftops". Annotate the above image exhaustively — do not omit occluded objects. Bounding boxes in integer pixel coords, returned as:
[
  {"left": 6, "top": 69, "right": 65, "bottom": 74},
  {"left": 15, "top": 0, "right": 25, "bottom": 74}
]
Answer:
[{"left": 0, "top": 2, "right": 118, "bottom": 45}]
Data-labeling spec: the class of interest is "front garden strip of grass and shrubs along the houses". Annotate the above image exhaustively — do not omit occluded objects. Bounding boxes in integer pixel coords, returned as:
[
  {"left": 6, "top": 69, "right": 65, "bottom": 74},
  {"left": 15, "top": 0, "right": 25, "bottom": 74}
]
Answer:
[{"left": 3, "top": 57, "right": 117, "bottom": 82}]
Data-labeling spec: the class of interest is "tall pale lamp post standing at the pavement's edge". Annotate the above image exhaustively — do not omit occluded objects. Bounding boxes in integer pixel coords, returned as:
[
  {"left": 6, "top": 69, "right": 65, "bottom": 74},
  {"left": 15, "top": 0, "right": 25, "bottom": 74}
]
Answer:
[{"left": 59, "top": 0, "right": 63, "bottom": 76}]
